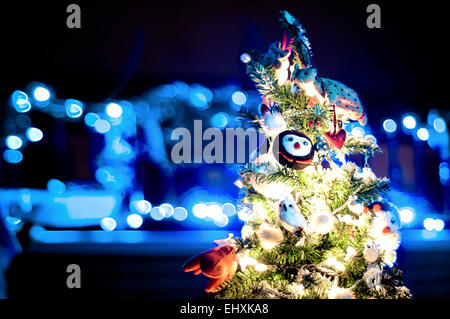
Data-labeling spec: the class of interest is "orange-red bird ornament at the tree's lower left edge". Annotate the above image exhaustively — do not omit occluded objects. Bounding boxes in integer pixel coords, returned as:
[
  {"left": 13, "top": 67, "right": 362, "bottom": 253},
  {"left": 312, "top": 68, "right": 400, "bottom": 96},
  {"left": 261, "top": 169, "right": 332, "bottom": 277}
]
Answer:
[{"left": 184, "top": 246, "right": 238, "bottom": 292}]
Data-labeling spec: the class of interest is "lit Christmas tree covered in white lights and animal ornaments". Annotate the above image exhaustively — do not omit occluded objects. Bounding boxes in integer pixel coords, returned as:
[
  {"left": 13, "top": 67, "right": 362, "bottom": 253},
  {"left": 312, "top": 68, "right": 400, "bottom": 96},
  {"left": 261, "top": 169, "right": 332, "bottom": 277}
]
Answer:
[{"left": 184, "top": 11, "right": 411, "bottom": 299}]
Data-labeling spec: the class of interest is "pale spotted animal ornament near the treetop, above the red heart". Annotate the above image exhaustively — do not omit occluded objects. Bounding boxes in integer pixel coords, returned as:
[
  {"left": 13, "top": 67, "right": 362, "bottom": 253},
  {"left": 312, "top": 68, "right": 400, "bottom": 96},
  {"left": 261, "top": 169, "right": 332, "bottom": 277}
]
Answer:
[{"left": 292, "top": 65, "right": 367, "bottom": 125}]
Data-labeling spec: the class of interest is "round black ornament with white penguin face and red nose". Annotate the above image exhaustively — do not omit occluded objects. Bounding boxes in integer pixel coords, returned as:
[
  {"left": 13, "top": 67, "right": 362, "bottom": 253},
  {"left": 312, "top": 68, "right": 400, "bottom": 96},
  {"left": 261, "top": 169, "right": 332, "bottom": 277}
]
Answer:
[{"left": 272, "top": 130, "right": 314, "bottom": 170}]
